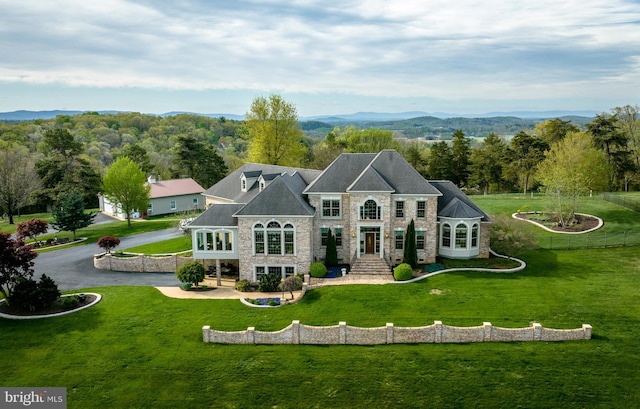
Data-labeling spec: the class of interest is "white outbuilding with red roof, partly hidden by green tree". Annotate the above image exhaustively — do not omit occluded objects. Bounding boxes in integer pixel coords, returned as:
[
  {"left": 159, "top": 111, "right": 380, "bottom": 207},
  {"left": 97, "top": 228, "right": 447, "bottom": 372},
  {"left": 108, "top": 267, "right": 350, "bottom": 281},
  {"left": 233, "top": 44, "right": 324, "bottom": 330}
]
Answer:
[{"left": 98, "top": 176, "right": 205, "bottom": 218}]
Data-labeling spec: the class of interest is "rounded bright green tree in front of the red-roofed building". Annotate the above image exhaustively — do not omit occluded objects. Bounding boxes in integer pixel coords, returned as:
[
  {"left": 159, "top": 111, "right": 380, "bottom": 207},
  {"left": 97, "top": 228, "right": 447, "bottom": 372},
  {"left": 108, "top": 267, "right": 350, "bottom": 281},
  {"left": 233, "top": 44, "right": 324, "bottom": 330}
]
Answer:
[{"left": 102, "top": 156, "right": 151, "bottom": 227}]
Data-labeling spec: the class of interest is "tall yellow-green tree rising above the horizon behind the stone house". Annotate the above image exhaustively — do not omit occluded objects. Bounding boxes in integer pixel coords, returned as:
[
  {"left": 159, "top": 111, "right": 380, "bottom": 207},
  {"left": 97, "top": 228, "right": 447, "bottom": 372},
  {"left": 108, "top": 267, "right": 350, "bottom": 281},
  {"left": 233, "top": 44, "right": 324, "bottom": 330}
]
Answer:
[{"left": 246, "top": 94, "right": 308, "bottom": 166}]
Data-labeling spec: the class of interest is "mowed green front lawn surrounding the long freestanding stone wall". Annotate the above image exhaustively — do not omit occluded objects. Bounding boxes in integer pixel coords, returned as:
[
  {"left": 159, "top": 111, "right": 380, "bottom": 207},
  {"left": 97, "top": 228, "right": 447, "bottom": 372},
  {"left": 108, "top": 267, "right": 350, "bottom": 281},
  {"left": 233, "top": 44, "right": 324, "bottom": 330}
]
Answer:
[{"left": 0, "top": 244, "right": 640, "bottom": 408}]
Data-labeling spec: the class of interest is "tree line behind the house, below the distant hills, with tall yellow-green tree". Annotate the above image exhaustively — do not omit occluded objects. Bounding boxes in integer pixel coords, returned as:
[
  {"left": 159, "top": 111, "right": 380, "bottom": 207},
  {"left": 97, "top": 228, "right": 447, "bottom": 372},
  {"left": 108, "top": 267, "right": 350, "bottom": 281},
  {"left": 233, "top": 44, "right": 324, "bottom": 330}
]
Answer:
[{"left": 0, "top": 95, "right": 640, "bottom": 228}]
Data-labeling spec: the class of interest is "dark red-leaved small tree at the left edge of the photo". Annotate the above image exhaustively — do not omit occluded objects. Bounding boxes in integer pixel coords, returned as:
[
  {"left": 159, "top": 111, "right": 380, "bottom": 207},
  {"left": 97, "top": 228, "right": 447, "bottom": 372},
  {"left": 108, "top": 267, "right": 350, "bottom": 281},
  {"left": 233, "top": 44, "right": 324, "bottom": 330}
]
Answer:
[{"left": 0, "top": 233, "right": 38, "bottom": 304}]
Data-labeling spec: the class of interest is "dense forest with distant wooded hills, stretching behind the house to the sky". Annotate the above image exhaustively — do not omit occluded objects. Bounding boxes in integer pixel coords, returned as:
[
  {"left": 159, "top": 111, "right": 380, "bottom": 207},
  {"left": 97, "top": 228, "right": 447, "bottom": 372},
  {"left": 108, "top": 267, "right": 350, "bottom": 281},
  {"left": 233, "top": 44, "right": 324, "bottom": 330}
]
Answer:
[{"left": 0, "top": 104, "right": 640, "bottom": 220}]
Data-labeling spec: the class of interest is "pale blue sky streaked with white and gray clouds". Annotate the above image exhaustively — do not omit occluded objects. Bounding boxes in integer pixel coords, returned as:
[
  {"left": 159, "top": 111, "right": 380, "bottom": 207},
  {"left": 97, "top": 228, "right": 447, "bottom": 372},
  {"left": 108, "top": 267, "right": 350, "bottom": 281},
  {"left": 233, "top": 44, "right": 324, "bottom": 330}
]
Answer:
[{"left": 0, "top": 0, "right": 640, "bottom": 116}]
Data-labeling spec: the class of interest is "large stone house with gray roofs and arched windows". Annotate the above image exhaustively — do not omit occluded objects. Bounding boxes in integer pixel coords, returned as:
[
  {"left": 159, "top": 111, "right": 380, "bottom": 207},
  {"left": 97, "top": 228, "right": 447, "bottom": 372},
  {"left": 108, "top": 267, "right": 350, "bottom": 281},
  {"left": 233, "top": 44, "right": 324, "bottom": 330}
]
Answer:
[{"left": 189, "top": 150, "right": 489, "bottom": 282}]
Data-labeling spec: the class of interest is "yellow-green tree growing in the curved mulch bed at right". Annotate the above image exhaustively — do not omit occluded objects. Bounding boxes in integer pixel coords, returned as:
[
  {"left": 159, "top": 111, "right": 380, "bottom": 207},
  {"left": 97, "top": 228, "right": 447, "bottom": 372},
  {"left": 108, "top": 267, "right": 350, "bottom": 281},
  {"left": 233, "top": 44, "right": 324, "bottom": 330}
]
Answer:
[{"left": 538, "top": 132, "right": 609, "bottom": 226}]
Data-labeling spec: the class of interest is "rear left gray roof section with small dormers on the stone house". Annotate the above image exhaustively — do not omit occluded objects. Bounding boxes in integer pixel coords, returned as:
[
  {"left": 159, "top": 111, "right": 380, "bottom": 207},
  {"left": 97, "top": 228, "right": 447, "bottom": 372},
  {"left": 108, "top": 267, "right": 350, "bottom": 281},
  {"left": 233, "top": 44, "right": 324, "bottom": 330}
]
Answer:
[{"left": 203, "top": 163, "right": 321, "bottom": 203}]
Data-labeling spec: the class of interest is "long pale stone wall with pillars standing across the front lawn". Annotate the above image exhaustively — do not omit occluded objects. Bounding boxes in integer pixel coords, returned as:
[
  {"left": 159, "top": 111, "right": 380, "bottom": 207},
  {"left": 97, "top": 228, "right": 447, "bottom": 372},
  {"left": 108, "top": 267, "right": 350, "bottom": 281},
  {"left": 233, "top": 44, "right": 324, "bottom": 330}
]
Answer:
[{"left": 202, "top": 320, "right": 591, "bottom": 345}]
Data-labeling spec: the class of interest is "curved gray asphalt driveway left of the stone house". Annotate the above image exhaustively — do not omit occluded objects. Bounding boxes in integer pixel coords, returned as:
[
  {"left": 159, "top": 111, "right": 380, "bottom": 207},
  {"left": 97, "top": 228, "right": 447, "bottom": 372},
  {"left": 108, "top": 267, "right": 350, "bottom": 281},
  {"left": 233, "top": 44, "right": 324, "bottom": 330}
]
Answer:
[{"left": 33, "top": 228, "right": 183, "bottom": 290}]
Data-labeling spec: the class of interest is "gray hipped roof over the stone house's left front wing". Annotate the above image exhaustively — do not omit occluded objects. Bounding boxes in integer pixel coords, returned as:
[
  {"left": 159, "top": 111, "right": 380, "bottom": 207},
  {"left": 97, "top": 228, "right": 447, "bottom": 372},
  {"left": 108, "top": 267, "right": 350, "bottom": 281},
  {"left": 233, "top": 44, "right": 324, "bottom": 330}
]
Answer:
[{"left": 235, "top": 173, "right": 315, "bottom": 216}]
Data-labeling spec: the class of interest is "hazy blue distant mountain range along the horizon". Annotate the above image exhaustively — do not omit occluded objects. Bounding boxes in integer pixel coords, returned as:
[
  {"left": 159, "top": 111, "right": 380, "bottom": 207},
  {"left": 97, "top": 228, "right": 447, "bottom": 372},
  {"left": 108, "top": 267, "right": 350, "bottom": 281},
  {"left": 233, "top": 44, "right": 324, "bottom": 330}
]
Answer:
[{"left": 0, "top": 110, "right": 600, "bottom": 123}]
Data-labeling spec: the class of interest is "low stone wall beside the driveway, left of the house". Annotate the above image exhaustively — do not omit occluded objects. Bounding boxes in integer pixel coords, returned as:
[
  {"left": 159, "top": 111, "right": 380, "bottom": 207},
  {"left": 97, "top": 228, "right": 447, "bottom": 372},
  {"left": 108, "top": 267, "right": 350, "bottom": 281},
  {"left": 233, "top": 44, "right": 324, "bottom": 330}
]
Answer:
[{"left": 93, "top": 254, "right": 193, "bottom": 273}]
